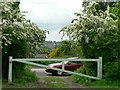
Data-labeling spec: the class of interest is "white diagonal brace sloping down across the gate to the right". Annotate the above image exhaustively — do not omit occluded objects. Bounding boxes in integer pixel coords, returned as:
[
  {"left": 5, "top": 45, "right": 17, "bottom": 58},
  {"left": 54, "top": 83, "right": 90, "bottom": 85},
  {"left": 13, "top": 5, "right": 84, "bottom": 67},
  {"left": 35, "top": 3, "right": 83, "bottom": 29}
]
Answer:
[{"left": 16, "top": 60, "right": 99, "bottom": 79}]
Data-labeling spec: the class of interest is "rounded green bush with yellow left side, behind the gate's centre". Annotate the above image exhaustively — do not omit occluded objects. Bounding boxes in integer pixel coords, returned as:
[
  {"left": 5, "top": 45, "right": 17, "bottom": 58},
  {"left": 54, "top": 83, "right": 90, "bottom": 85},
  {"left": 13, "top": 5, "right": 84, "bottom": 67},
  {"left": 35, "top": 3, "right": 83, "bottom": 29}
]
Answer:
[{"left": 49, "top": 40, "right": 82, "bottom": 58}]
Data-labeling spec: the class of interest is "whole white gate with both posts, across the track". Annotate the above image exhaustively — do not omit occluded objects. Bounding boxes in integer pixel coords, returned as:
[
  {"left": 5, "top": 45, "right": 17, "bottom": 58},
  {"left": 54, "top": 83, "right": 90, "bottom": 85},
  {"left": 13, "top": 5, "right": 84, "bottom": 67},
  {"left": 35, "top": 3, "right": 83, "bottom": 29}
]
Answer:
[{"left": 8, "top": 56, "right": 102, "bottom": 83}]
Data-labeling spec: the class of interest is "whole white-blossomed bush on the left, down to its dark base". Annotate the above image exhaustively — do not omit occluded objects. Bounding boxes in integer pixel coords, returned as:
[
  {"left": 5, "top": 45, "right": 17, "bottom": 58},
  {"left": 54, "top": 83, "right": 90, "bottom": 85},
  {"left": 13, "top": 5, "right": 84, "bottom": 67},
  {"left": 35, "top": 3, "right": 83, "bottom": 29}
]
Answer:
[{"left": 0, "top": 2, "right": 46, "bottom": 79}]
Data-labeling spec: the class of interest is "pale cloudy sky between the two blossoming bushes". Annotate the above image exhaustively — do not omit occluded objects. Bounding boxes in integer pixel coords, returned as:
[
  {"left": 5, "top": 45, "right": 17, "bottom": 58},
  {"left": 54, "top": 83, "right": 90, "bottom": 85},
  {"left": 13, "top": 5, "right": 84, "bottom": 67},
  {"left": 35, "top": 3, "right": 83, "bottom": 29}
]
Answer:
[{"left": 20, "top": 0, "right": 82, "bottom": 41}]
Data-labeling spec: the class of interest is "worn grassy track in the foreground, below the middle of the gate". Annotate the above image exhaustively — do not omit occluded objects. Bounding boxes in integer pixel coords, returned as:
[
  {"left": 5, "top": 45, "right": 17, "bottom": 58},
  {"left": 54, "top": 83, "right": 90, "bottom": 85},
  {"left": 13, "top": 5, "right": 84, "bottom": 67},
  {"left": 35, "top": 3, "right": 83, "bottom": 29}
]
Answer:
[{"left": 38, "top": 76, "right": 84, "bottom": 88}]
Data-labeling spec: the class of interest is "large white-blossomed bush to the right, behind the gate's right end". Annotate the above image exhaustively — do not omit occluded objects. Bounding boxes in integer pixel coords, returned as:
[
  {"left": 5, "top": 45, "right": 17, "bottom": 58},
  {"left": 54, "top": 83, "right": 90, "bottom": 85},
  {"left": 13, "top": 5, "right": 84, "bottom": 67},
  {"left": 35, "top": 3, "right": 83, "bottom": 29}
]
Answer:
[{"left": 61, "top": 2, "right": 120, "bottom": 80}]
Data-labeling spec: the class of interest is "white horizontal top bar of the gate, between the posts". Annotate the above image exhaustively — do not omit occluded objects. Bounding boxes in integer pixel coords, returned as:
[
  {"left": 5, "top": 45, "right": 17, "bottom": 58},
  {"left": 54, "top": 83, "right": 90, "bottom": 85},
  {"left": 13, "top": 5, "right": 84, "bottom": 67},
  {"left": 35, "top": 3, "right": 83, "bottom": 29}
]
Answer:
[{"left": 12, "top": 58, "right": 99, "bottom": 61}]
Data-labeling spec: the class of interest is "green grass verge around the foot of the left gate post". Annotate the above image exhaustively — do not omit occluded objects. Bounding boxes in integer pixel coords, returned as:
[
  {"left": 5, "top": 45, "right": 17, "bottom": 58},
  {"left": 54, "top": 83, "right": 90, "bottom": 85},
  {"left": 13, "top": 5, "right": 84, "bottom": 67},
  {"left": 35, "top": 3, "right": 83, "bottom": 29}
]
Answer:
[{"left": 2, "top": 66, "right": 38, "bottom": 88}]
